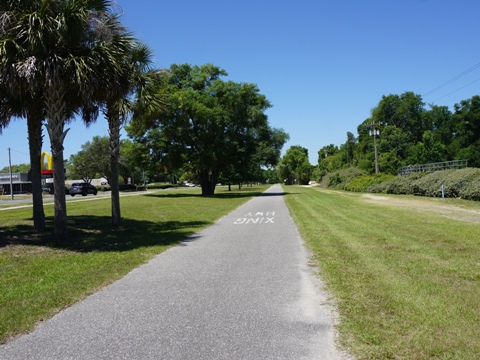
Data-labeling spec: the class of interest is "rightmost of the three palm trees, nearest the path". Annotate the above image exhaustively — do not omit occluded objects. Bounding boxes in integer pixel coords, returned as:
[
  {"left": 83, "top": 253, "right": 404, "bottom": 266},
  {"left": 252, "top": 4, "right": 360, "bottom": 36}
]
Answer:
[{"left": 104, "top": 41, "right": 160, "bottom": 228}]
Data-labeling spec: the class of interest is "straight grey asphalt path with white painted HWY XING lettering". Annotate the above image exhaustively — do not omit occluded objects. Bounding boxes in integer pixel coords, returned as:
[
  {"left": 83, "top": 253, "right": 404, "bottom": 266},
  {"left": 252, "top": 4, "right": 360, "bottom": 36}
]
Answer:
[{"left": 0, "top": 185, "right": 341, "bottom": 360}]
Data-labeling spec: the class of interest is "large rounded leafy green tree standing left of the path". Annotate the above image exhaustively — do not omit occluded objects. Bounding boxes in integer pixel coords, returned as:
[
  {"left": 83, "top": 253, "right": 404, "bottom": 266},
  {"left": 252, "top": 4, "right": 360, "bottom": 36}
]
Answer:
[{"left": 130, "top": 64, "right": 283, "bottom": 196}]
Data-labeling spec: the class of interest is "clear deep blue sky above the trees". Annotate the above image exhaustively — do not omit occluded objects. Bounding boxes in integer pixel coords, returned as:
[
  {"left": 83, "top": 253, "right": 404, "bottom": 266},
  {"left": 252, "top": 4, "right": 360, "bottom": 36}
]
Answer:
[{"left": 0, "top": 0, "right": 480, "bottom": 168}]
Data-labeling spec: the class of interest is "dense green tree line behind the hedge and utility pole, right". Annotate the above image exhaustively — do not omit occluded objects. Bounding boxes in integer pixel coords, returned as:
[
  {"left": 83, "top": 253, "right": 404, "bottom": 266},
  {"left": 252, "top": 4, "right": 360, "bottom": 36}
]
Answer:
[{"left": 279, "top": 92, "right": 480, "bottom": 184}]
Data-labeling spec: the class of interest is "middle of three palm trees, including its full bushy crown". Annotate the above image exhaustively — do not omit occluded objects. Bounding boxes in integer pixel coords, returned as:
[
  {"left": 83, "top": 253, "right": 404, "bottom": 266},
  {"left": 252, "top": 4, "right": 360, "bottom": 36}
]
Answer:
[{"left": 0, "top": 0, "right": 128, "bottom": 242}]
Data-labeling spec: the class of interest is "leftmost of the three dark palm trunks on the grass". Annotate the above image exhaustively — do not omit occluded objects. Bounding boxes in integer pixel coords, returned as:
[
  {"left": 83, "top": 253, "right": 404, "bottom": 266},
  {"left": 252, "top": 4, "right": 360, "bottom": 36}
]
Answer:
[{"left": 27, "top": 108, "right": 45, "bottom": 231}]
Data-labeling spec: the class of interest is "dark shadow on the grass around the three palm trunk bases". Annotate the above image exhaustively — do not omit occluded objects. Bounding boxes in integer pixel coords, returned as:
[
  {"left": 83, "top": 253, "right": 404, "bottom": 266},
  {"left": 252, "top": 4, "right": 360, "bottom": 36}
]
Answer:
[{"left": 0, "top": 216, "right": 209, "bottom": 252}]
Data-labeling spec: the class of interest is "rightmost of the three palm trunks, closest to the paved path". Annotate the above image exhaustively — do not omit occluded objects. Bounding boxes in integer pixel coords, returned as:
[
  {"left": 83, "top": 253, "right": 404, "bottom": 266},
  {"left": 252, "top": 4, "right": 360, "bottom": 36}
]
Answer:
[{"left": 105, "top": 107, "right": 122, "bottom": 229}]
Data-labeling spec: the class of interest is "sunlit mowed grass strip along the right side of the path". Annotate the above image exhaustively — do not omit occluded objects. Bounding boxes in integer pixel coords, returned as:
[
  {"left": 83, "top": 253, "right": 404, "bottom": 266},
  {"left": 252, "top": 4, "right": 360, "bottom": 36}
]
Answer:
[{"left": 284, "top": 187, "right": 480, "bottom": 359}]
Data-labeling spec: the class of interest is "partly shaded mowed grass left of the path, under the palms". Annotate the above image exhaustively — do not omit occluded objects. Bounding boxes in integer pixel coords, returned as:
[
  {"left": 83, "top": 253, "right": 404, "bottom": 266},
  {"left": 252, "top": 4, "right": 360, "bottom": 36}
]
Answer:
[{"left": 0, "top": 186, "right": 267, "bottom": 343}]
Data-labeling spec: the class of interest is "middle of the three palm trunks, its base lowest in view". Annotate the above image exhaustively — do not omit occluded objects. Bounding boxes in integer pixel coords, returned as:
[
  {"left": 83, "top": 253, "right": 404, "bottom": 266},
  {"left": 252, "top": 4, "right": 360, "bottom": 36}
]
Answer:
[{"left": 44, "top": 86, "right": 69, "bottom": 244}]
